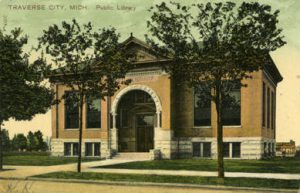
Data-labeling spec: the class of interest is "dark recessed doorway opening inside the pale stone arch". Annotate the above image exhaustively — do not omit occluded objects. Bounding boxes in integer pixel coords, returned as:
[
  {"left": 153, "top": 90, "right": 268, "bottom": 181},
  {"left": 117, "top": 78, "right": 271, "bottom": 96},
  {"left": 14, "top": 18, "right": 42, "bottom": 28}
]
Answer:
[{"left": 116, "top": 90, "right": 157, "bottom": 152}]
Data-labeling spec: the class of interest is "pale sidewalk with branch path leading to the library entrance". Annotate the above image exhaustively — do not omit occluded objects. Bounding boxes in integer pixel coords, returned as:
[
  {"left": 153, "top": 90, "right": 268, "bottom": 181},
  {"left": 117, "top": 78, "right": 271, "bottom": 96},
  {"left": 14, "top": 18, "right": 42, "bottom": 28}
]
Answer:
[{"left": 0, "top": 159, "right": 300, "bottom": 180}]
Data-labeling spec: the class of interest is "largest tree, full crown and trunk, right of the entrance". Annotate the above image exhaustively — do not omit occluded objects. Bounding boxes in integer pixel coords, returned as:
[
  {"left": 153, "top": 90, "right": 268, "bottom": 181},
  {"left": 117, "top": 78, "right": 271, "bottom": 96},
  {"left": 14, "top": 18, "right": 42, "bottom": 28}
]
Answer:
[{"left": 146, "top": 2, "right": 285, "bottom": 178}]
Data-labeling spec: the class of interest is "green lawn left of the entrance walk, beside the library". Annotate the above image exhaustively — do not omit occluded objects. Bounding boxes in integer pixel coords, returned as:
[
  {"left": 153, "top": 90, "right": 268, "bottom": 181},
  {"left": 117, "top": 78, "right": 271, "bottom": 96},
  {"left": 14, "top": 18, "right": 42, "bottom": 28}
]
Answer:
[{"left": 3, "top": 152, "right": 99, "bottom": 166}]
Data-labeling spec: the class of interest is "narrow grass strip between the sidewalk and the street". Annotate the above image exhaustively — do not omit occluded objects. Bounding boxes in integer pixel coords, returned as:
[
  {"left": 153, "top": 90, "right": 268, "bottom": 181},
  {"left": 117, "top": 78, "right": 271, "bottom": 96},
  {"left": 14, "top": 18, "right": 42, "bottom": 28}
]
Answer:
[{"left": 34, "top": 172, "right": 300, "bottom": 189}]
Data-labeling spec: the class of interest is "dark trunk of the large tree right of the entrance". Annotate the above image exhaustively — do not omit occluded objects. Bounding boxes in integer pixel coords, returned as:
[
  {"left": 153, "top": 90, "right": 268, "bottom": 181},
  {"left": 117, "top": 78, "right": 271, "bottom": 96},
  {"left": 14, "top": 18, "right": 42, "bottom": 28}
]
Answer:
[{"left": 215, "top": 84, "right": 224, "bottom": 178}]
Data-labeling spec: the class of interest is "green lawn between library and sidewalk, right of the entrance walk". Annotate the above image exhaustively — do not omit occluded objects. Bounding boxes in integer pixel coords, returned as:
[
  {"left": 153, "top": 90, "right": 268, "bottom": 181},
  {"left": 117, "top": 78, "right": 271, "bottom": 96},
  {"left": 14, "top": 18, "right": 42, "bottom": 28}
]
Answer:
[{"left": 99, "top": 158, "right": 300, "bottom": 173}]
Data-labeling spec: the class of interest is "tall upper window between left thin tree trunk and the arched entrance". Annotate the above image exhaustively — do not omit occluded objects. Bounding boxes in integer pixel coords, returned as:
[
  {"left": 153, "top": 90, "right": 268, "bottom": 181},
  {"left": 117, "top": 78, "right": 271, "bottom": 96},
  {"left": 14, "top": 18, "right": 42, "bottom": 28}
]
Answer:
[{"left": 86, "top": 96, "right": 101, "bottom": 128}]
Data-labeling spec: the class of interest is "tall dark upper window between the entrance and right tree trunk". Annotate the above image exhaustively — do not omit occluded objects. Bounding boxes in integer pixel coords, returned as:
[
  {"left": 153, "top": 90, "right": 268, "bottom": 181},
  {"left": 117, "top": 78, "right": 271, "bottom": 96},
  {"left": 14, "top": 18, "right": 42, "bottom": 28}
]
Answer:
[{"left": 194, "top": 84, "right": 211, "bottom": 126}]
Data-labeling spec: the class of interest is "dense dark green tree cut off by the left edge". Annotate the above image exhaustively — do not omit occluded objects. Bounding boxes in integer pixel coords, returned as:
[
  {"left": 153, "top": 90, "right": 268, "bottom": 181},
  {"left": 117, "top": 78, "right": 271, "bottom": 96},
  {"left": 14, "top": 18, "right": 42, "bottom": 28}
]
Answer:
[{"left": 0, "top": 28, "right": 53, "bottom": 170}]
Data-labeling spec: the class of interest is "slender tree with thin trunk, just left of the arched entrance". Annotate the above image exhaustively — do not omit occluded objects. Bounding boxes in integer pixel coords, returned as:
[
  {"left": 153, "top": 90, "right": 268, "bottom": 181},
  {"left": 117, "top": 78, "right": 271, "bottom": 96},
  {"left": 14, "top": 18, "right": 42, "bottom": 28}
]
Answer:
[{"left": 39, "top": 19, "right": 131, "bottom": 172}]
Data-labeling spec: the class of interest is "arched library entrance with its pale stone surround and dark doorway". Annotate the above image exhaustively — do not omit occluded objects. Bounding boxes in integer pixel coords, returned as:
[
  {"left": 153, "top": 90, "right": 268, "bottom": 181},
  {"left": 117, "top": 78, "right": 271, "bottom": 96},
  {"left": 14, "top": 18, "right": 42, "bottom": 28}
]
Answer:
[{"left": 110, "top": 85, "right": 162, "bottom": 152}]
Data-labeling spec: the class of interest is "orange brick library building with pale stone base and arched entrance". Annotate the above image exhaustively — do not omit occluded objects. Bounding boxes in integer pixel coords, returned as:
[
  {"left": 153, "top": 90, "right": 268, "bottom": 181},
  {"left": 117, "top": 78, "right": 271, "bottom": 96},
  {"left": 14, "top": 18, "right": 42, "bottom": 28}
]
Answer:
[{"left": 51, "top": 37, "right": 282, "bottom": 159}]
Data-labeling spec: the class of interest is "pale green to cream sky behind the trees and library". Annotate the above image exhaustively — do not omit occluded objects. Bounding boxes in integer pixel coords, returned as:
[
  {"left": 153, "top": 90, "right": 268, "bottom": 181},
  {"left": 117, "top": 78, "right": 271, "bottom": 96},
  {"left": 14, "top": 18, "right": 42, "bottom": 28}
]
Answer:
[{"left": 0, "top": 0, "right": 300, "bottom": 145}]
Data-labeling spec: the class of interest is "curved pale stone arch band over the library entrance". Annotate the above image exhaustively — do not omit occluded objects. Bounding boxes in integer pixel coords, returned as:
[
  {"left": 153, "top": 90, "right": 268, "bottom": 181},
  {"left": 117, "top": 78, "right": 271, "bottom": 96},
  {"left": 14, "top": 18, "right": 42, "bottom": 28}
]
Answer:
[{"left": 111, "top": 84, "right": 162, "bottom": 115}]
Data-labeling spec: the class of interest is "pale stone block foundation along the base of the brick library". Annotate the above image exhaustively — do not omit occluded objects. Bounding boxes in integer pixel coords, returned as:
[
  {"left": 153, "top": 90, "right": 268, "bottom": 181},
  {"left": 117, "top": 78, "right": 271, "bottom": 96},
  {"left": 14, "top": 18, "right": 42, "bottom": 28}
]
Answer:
[{"left": 51, "top": 137, "right": 275, "bottom": 159}]
